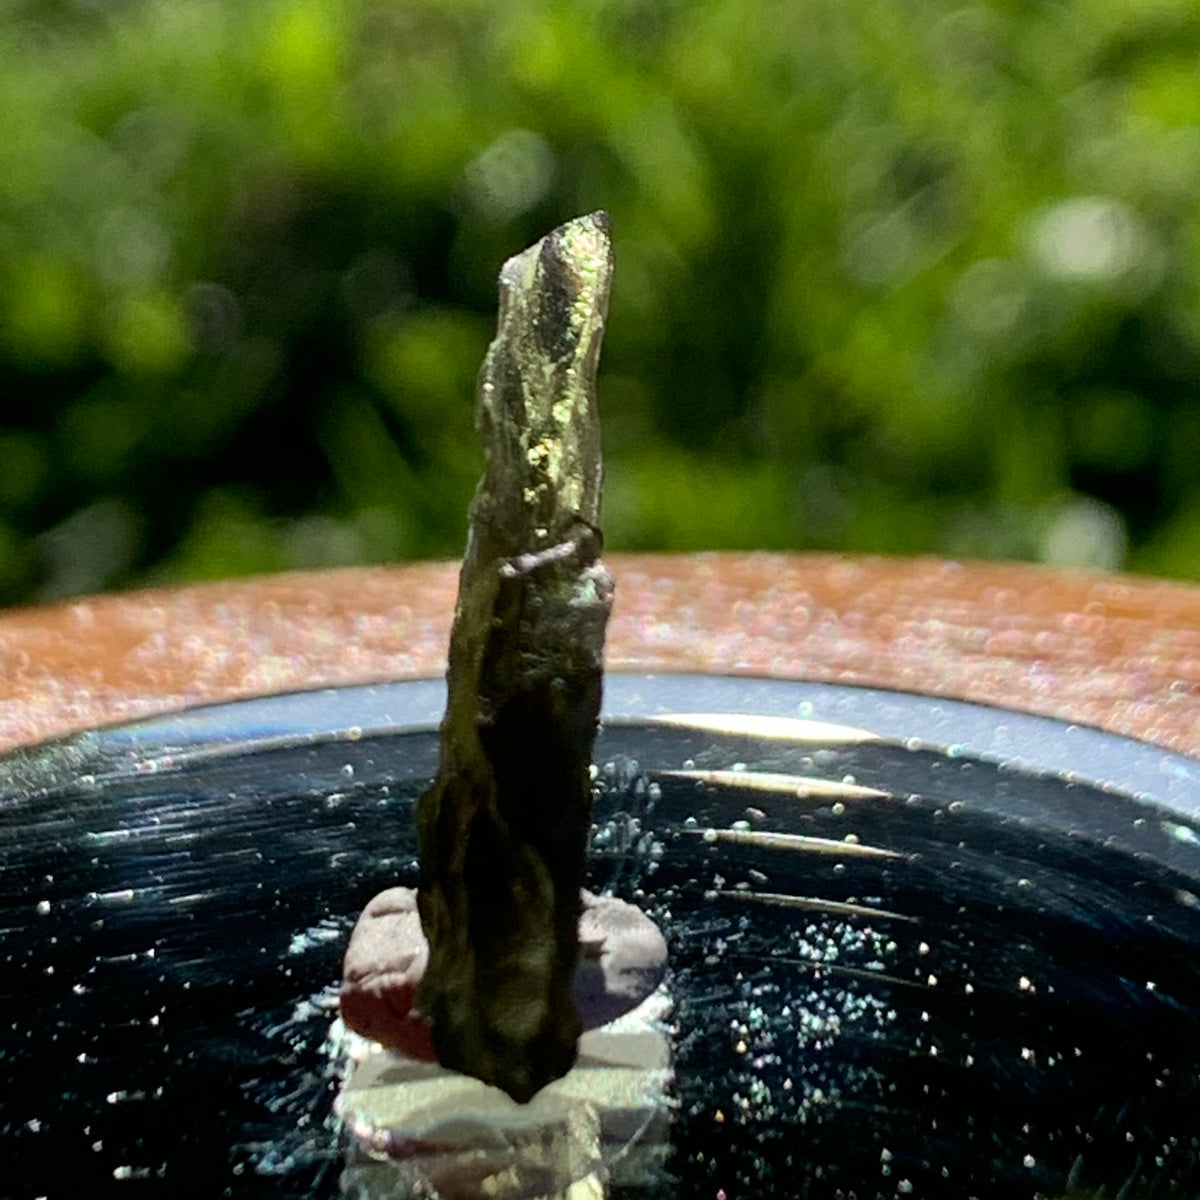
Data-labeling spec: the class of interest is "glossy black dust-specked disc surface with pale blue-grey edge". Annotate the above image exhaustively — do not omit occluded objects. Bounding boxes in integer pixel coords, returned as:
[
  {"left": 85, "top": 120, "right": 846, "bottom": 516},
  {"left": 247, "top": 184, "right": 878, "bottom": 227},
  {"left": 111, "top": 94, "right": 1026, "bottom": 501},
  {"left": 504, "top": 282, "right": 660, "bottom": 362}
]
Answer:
[{"left": 0, "top": 676, "right": 1200, "bottom": 1200}]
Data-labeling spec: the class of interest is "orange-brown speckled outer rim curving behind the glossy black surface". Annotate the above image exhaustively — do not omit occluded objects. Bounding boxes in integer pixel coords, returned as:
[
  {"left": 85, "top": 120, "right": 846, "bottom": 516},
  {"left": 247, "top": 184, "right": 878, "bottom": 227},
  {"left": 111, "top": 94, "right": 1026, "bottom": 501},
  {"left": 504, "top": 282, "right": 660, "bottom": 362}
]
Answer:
[{"left": 0, "top": 554, "right": 1200, "bottom": 752}]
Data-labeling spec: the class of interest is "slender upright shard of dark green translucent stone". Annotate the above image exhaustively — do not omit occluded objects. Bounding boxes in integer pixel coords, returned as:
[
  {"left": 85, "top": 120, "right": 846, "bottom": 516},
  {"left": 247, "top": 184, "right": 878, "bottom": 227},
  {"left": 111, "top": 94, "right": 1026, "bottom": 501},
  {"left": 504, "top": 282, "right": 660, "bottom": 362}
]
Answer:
[{"left": 418, "top": 212, "right": 612, "bottom": 1100}]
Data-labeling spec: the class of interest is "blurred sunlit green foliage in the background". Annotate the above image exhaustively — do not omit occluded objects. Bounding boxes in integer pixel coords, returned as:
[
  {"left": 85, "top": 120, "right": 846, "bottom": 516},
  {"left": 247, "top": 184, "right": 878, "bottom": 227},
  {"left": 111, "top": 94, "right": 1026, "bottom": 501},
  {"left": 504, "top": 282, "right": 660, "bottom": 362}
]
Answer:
[{"left": 0, "top": 0, "right": 1200, "bottom": 602}]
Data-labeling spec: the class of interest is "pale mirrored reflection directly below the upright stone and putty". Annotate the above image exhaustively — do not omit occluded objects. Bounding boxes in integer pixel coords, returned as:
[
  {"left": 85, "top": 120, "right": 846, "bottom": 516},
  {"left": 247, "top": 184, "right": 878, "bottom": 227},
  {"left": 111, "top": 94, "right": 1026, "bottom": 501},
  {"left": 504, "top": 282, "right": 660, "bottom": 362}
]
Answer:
[{"left": 337, "top": 988, "right": 671, "bottom": 1200}]
